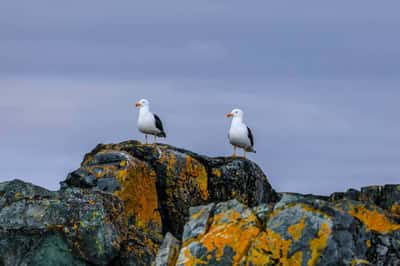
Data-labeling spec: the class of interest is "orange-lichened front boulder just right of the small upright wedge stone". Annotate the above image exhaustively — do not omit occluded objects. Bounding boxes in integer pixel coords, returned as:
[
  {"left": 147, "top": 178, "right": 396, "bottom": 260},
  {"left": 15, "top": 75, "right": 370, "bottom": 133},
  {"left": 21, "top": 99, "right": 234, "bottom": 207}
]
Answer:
[{"left": 177, "top": 200, "right": 260, "bottom": 265}]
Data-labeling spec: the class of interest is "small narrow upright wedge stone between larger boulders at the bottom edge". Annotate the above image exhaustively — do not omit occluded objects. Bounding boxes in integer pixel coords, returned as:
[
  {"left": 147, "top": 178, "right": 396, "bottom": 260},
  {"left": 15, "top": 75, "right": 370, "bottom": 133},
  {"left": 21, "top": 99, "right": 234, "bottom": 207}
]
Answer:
[{"left": 156, "top": 233, "right": 180, "bottom": 266}]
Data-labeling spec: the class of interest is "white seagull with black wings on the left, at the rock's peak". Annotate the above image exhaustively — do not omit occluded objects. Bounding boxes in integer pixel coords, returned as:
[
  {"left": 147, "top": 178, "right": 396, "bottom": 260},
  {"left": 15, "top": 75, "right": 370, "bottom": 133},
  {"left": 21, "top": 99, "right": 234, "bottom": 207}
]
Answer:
[{"left": 136, "top": 99, "right": 167, "bottom": 144}]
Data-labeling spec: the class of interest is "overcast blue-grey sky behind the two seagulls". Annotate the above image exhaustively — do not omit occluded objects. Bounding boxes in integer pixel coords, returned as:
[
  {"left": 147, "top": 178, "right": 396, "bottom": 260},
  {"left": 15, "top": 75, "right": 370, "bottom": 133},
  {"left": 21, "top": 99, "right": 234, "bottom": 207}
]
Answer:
[{"left": 0, "top": 0, "right": 400, "bottom": 194}]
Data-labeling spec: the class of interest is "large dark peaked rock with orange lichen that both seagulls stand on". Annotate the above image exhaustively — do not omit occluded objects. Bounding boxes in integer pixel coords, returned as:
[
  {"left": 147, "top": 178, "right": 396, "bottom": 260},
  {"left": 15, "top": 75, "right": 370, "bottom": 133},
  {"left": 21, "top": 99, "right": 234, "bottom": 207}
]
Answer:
[{"left": 63, "top": 141, "right": 276, "bottom": 265}]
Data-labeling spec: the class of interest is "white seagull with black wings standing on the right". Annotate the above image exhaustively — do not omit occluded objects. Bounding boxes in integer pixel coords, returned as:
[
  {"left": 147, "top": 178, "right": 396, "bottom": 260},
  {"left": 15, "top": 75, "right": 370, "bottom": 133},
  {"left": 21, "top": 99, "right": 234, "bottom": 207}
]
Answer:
[{"left": 226, "top": 109, "right": 256, "bottom": 158}]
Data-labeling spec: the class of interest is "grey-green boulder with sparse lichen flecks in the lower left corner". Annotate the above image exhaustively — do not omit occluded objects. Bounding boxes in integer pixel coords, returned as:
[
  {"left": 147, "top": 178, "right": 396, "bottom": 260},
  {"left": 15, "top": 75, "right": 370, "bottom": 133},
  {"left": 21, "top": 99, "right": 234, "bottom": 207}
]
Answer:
[{"left": 0, "top": 180, "right": 126, "bottom": 265}]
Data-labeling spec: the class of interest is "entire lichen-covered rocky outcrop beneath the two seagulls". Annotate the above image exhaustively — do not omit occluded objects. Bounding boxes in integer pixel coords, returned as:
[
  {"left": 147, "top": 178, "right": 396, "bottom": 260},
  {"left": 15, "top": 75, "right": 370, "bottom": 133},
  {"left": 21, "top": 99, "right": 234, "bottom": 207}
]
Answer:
[{"left": 0, "top": 141, "right": 400, "bottom": 265}]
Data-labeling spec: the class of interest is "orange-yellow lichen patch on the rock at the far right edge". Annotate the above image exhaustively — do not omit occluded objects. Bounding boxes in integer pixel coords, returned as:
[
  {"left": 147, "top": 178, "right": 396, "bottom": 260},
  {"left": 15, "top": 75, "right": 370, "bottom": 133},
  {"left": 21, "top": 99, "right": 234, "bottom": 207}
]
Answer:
[{"left": 348, "top": 205, "right": 400, "bottom": 233}]
